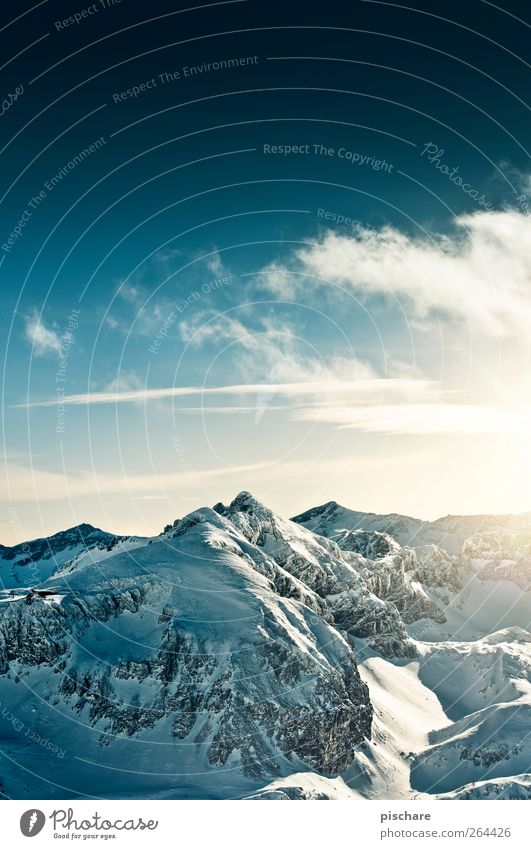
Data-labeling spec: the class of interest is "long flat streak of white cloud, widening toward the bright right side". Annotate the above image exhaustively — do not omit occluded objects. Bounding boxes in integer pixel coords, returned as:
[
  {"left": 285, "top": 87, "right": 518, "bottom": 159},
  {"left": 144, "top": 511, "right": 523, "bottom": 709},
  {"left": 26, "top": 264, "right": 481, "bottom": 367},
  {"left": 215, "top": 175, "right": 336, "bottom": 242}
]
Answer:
[{"left": 20, "top": 378, "right": 531, "bottom": 436}]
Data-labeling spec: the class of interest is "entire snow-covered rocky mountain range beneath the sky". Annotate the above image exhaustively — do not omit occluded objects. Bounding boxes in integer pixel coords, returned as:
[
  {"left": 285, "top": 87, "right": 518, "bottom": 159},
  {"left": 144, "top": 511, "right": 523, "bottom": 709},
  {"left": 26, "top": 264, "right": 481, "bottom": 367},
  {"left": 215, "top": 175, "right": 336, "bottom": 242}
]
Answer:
[{"left": 0, "top": 492, "right": 531, "bottom": 799}]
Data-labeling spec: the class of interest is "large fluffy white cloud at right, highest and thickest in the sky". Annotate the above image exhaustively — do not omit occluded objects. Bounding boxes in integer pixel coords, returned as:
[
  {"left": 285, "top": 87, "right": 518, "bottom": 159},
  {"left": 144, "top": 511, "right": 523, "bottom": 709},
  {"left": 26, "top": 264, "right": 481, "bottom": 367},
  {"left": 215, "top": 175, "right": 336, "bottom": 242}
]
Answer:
[{"left": 260, "top": 210, "right": 531, "bottom": 341}]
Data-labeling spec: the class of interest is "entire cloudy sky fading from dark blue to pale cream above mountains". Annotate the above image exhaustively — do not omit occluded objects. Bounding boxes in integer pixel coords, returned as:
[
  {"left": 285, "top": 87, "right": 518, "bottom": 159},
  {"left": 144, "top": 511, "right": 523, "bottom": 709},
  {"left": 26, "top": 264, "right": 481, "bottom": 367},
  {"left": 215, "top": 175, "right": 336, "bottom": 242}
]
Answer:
[{"left": 0, "top": 0, "right": 531, "bottom": 544}]
